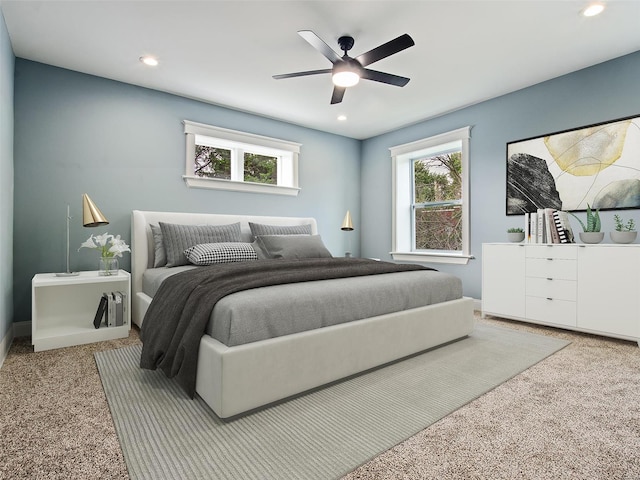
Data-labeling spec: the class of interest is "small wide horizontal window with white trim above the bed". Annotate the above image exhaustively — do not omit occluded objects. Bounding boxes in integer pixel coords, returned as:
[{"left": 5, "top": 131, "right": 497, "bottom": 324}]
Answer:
[{"left": 183, "top": 120, "right": 300, "bottom": 195}]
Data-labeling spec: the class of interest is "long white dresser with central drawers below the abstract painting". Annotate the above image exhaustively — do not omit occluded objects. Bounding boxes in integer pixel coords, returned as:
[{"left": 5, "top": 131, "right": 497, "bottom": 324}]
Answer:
[{"left": 482, "top": 243, "right": 640, "bottom": 346}]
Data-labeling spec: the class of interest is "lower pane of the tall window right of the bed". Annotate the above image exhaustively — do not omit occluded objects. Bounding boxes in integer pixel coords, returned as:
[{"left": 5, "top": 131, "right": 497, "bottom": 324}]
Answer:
[{"left": 415, "top": 205, "right": 462, "bottom": 250}]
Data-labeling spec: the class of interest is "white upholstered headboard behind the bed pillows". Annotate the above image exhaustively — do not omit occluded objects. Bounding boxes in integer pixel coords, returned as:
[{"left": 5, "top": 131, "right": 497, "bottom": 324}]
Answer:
[{"left": 131, "top": 210, "right": 318, "bottom": 326}]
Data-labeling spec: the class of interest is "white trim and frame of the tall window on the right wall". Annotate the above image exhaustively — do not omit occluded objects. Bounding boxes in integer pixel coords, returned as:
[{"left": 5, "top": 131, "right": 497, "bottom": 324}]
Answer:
[{"left": 389, "top": 127, "right": 473, "bottom": 265}]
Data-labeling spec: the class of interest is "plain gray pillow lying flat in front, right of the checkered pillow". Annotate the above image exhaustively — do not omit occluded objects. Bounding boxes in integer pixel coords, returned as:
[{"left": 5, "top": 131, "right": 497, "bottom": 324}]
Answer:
[{"left": 256, "top": 235, "right": 332, "bottom": 259}]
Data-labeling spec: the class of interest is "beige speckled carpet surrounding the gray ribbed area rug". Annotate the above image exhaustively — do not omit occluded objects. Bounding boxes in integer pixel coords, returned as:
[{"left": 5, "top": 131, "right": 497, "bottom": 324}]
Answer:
[{"left": 0, "top": 319, "right": 640, "bottom": 480}]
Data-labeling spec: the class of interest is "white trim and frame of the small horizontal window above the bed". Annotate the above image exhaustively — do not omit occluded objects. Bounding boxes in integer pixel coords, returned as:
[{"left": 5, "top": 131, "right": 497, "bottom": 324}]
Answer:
[{"left": 182, "top": 120, "right": 301, "bottom": 196}]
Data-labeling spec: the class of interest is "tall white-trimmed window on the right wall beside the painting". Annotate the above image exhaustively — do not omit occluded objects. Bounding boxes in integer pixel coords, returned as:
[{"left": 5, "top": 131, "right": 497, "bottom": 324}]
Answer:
[{"left": 390, "top": 127, "right": 471, "bottom": 264}]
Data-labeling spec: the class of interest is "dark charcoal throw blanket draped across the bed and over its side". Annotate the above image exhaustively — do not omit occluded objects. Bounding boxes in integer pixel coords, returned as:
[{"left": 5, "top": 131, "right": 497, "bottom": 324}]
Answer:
[{"left": 140, "top": 258, "right": 430, "bottom": 398}]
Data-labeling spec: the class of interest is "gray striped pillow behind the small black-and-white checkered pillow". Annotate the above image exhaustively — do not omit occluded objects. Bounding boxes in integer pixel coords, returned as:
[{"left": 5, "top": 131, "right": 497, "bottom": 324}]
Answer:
[{"left": 160, "top": 222, "right": 241, "bottom": 267}]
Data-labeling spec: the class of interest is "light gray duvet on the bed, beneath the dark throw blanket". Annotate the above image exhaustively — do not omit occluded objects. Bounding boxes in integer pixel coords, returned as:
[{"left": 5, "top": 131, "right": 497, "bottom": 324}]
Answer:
[{"left": 143, "top": 266, "right": 462, "bottom": 346}]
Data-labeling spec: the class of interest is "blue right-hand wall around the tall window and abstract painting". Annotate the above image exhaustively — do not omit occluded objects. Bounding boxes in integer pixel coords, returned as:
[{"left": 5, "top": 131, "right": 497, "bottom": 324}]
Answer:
[{"left": 361, "top": 52, "right": 640, "bottom": 298}]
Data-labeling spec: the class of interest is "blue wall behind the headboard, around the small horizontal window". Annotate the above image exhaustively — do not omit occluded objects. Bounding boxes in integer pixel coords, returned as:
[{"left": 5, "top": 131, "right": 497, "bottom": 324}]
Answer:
[{"left": 14, "top": 59, "right": 361, "bottom": 321}]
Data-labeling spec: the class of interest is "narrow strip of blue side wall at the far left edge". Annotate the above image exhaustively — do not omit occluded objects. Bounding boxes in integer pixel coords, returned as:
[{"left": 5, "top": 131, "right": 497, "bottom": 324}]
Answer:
[{"left": 0, "top": 11, "right": 15, "bottom": 342}]
